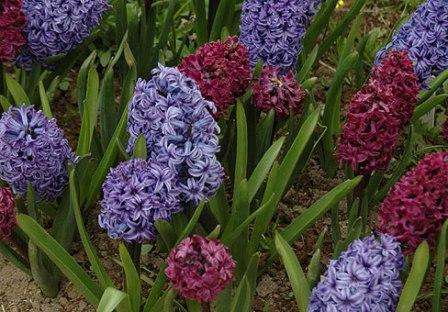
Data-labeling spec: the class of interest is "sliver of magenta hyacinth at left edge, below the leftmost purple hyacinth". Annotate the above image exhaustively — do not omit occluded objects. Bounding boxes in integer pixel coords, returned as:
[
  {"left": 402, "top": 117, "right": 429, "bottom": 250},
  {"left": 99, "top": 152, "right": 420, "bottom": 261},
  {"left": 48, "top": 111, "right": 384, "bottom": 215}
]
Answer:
[{"left": 0, "top": 187, "right": 17, "bottom": 241}]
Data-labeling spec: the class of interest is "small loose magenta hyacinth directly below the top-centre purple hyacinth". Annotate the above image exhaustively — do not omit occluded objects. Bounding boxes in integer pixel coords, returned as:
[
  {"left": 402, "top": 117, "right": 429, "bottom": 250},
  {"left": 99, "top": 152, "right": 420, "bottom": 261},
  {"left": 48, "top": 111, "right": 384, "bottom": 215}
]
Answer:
[{"left": 252, "top": 66, "right": 306, "bottom": 118}]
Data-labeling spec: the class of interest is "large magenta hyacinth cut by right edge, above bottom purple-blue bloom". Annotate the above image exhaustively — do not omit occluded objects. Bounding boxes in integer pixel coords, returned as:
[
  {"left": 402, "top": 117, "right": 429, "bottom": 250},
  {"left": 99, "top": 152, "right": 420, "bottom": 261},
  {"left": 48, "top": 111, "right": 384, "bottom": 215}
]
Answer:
[{"left": 378, "top": 152, "right": 448, "bottom": 252}]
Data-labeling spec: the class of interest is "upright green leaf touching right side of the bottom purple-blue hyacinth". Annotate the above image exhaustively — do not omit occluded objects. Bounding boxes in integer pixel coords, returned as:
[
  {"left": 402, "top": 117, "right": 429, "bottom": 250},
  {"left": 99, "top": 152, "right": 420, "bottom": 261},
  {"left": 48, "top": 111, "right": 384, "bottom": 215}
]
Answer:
[{"left": 397, "top": 241, "right": 429, "bottom": 312}]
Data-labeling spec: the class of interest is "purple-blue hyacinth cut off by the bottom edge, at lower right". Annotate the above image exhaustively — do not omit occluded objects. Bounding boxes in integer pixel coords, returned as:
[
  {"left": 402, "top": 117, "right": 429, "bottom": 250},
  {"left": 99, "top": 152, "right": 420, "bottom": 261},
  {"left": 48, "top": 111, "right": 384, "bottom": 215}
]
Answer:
[{"left": 308, "top": 235, "right": 404, "bottom": 312}]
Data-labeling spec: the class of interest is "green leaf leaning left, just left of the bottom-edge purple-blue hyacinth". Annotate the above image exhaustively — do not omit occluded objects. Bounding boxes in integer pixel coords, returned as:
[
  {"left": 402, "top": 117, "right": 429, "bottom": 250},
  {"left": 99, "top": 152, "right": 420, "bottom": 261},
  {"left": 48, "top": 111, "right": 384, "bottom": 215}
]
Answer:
[{"left": 275, "top": 233, "right": 310, "bottom": 312}]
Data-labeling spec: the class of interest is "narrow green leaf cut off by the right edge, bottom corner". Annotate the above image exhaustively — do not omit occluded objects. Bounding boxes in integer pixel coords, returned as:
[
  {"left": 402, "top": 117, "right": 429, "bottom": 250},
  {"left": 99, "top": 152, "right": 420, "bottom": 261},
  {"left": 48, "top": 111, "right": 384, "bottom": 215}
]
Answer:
[{"left": 432, "top": 220, "right": 448, "bottom": 312}]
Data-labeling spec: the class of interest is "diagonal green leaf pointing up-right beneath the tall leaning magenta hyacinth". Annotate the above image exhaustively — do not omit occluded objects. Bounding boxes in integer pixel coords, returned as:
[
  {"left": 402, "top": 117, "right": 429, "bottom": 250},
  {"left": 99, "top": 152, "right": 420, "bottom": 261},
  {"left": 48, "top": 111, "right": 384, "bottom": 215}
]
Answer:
[{"left": 282, "top": 176, "right": 362, "bottom": 243}]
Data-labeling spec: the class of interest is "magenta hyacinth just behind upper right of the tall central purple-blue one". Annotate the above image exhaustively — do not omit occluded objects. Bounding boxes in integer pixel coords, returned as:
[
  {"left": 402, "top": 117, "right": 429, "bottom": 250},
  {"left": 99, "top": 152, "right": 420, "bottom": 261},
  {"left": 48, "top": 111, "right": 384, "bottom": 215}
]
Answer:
[{"left": 179, "top": 37, "right": 250, "bottom": 115}]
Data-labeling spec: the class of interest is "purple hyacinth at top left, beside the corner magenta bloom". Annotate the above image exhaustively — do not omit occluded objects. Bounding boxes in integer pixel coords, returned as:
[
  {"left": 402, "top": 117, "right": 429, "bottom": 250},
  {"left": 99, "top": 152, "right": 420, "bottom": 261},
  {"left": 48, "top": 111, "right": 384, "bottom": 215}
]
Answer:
[{"left": 23, "top": 0, "right": 109, "bottom": 60}]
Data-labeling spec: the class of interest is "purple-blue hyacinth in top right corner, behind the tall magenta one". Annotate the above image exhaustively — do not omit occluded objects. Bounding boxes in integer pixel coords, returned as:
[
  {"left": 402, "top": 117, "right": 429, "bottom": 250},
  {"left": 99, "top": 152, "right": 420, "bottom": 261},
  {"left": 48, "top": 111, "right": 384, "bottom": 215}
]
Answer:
[{"left": 377, "top": 0, "right": 448, "bottom": 85}]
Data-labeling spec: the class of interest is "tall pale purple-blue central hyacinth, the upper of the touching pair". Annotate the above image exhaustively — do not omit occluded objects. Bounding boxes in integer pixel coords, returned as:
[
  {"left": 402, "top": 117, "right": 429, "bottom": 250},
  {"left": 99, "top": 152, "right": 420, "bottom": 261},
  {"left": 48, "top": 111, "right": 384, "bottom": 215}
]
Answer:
[{"left": 128, "top": 65, "right": 224, "bottom": 203}]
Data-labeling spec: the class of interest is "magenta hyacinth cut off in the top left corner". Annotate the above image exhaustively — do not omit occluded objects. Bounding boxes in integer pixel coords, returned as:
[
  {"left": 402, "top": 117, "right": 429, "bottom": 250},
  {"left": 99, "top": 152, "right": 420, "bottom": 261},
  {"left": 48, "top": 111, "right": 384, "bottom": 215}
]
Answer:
[{"left": 0, "top": 0, "right": 26, "bottom": 62}]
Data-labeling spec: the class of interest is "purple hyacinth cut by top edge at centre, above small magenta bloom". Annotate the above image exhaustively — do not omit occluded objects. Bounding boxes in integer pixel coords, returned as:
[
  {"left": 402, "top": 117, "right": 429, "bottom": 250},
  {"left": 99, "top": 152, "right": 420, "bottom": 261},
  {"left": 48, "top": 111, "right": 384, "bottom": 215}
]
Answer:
[{"left": 240, "top": 0, "right": 322, "bottom": 69}]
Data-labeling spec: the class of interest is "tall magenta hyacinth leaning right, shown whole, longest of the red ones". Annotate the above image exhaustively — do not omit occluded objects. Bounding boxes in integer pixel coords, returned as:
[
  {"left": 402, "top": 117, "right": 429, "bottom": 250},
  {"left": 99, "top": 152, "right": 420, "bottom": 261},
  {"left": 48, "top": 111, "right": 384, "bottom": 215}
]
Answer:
[{"left": 338, "top": 51, "right": 420, "bottom": 174}]
